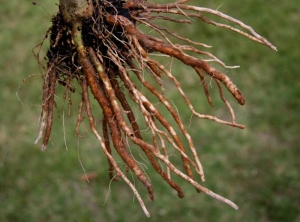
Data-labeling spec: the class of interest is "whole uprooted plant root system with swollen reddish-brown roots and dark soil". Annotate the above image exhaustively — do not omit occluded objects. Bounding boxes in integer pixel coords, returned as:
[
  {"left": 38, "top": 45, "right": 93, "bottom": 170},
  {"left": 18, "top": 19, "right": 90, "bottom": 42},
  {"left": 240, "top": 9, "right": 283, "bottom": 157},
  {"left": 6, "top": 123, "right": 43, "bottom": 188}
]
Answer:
[{"left": 35, "top": 0, "right": 276, "bottom": 216}]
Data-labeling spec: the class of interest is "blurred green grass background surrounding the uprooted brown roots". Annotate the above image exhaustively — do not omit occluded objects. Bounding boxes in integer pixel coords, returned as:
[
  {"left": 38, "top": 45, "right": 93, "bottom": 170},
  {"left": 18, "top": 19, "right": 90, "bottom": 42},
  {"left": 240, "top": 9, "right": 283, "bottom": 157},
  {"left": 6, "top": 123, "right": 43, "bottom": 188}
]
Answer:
[{"left": 0, "top": 0, "right": 300, "bottom": 222}]
